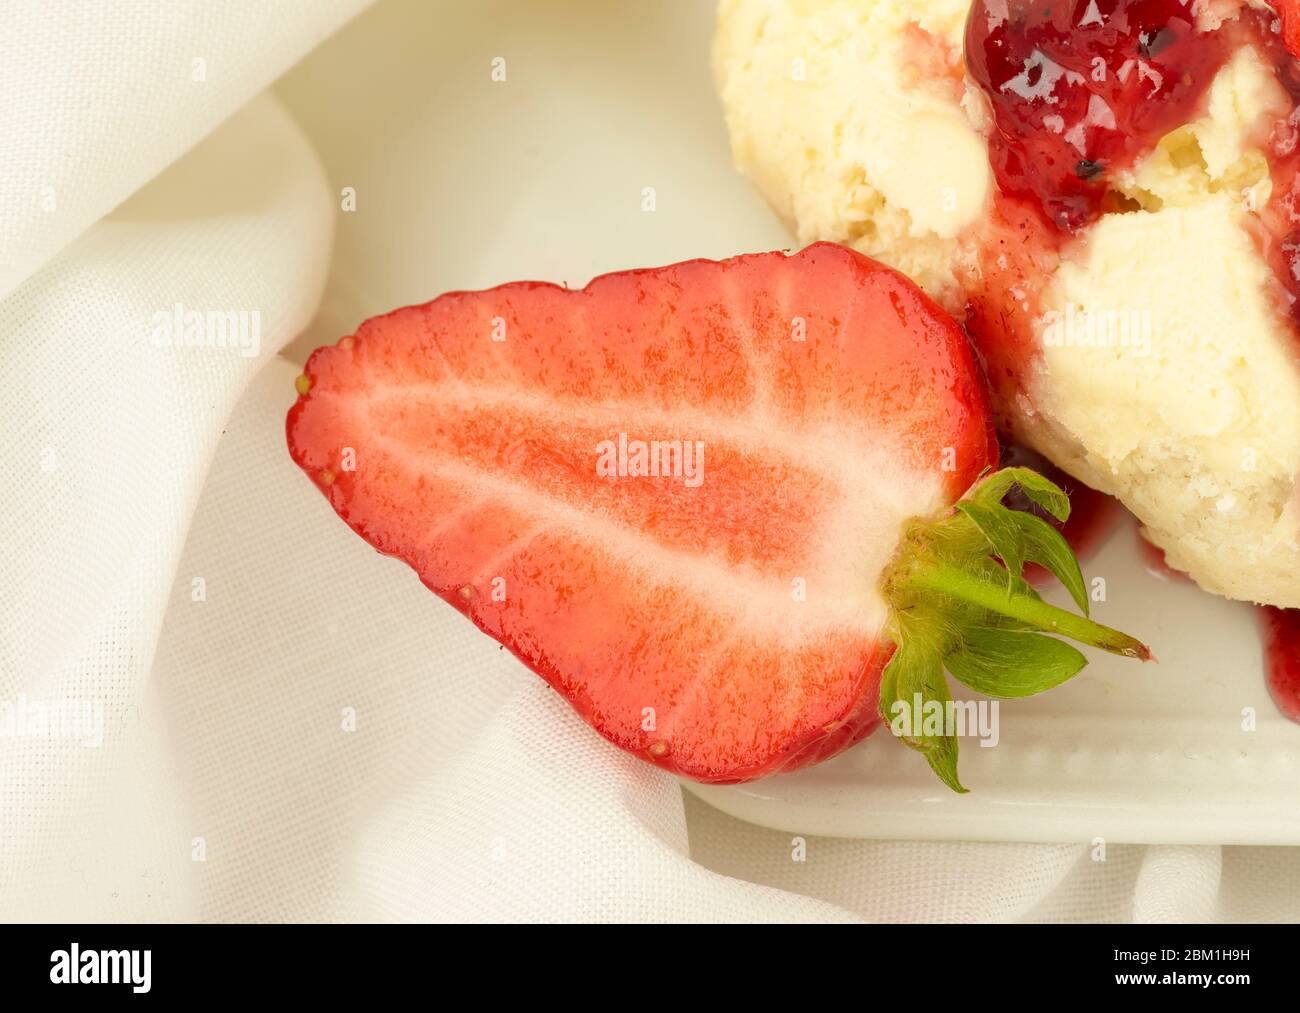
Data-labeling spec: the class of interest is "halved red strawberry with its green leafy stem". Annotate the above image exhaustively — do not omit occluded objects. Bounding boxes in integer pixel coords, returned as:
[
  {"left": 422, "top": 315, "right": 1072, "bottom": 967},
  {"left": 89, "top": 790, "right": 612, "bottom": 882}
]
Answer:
[{"left": 287, "top": 243, "right": 1140, "bottom": 787}]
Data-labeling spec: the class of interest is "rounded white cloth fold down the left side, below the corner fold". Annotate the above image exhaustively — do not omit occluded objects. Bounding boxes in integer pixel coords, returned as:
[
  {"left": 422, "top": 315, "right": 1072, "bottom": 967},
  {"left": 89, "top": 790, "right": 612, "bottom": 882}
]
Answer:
[{"left": 0, "top": 98, "right": 334, "bottom": 919}]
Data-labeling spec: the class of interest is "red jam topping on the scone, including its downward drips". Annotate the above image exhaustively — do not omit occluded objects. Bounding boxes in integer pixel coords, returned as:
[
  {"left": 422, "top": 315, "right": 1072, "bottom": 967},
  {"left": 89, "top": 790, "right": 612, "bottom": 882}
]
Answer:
[{"left": 958, "top": 0, "right": 1300, "bottom": 392}]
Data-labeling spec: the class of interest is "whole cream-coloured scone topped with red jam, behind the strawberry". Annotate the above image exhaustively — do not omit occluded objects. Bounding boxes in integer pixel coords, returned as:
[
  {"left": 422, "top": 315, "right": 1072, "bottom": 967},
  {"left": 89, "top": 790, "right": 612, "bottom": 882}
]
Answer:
[{"left": 714, "top": 0, "right": 1300, "bottom": 607}]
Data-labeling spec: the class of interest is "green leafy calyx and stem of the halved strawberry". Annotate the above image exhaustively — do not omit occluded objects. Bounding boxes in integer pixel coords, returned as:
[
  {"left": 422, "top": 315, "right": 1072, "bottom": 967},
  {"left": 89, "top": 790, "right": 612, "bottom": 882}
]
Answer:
[{"left": 880, "top": 468, "right": 1152, "bottom": 792}]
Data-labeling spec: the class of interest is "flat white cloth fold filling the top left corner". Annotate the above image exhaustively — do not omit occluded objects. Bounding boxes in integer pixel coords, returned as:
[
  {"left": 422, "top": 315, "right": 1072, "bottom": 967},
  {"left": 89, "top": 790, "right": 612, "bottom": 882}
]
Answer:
[{"left": 0, "top": 0, "right": 371, "bottom": 299}]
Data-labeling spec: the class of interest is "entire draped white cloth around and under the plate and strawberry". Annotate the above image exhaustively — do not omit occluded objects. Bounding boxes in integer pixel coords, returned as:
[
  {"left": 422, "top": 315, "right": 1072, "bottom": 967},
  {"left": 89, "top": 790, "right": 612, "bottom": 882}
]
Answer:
[{"left": 0, "top": 0, "right": 1300, "bottom": 922}]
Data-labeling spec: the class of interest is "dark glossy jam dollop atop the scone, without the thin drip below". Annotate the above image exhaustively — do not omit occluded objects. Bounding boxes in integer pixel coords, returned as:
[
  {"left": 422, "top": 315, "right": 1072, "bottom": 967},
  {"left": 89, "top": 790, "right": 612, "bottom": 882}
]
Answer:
[{"left": 966, "top": 0, "right": 1231, "bottom": 231}]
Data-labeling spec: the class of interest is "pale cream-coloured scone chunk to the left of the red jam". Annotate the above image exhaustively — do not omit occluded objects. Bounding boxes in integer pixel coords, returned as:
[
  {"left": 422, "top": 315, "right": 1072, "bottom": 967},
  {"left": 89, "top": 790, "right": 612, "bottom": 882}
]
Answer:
[{"left": 714, "top": 0, "right": 993, "bottom": 309}]
